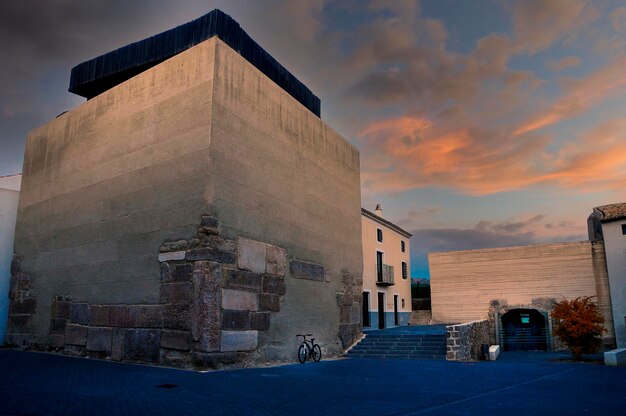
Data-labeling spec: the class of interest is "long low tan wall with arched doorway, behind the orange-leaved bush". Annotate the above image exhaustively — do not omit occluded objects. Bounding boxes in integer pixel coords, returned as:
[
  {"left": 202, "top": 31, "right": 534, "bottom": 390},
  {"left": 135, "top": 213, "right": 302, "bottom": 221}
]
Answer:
[{"left": 428, "top": 241, "right": 615, "bottom": 351}]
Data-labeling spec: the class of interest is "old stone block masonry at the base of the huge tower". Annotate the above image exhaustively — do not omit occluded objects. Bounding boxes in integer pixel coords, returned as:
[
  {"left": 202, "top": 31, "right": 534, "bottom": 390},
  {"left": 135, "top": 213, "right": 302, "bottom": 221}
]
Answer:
[{"left": 6, "top": 215, "right": 336, "bottom": 368}]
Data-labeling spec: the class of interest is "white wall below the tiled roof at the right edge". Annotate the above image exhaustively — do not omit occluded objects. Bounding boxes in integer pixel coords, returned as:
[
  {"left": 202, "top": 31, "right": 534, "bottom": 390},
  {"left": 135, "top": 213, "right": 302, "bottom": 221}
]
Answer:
[{"left": 602, "top": 220, "right": 626, "bottom": 348}]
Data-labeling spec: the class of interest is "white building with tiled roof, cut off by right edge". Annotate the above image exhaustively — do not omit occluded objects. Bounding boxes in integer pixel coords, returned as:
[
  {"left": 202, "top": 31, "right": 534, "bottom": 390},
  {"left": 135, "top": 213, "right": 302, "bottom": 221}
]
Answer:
[{"left": 587, "top": 202, "right": 626, "bottom": 348}]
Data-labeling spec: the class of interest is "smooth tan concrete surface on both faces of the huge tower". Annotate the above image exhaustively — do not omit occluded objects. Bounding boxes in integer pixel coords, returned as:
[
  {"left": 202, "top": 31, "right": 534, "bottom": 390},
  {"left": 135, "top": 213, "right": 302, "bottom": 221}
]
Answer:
[{"left": 6, "top": 38, "right": 362, "bottom": 366}]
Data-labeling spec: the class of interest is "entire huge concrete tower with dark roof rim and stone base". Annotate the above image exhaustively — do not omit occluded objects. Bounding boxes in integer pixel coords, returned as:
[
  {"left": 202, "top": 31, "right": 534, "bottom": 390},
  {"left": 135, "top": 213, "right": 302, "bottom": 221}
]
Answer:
[{"left": 6, "top": 11, "right": 363, "bottom": 367}]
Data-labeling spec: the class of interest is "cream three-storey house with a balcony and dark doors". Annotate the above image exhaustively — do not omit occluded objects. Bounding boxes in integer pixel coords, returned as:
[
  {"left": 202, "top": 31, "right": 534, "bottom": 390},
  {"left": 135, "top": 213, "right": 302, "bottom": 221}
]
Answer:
[{"left": 361, "top": 205, "right": 411, "bottom": 329}]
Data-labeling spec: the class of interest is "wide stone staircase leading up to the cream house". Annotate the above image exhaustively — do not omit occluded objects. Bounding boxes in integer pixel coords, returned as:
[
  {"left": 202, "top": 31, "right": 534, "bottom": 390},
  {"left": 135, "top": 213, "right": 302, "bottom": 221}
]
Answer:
[{"left": 346, "top": 330, "right": 446, "bottom": 360}]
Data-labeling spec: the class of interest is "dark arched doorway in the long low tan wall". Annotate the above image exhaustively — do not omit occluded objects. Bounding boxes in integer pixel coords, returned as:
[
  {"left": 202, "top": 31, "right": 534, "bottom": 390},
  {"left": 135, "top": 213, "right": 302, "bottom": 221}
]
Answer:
[{"left": 499, "top": 309, "right": 548, "bottom": 351}]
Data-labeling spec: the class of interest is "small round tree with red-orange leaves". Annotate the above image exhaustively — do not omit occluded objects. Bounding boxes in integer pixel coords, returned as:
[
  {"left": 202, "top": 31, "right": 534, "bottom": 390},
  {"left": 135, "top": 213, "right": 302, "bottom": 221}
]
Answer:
[{"left": 552, "top": 296, "right": 606, "bottom": 360}]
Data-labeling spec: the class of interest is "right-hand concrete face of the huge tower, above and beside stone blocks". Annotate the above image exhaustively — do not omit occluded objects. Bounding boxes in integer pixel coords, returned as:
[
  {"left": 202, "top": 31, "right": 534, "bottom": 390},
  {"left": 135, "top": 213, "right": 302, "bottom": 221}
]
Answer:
[{"left": 207, "top": 41, "right": 363, "bottom": 358}]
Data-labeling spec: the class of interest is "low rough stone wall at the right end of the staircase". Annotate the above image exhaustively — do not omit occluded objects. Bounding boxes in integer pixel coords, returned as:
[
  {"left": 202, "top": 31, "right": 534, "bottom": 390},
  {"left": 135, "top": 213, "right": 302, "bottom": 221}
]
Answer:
[{"left": 446, "top": 320, "right": 489, "bottom": 361}]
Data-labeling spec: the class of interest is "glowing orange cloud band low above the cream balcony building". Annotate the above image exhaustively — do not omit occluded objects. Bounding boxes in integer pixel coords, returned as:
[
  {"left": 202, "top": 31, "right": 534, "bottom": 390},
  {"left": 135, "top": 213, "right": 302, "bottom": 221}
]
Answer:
[{"left": 360, "top": 116, "right": 626, "bottom": 195}]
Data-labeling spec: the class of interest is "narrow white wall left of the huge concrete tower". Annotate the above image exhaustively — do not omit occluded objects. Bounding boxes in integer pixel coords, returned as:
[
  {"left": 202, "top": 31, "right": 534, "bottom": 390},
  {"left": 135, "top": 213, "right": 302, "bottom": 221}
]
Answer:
[{"left": 0, "top": 175, "right": 22, "bottom": 345}]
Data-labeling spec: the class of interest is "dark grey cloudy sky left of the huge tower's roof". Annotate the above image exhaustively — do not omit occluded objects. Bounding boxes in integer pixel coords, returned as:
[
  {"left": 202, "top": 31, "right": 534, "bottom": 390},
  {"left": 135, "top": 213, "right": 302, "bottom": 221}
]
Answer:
[{"left": 0, "top": 0, "right": 212, "bottom": 175}]
